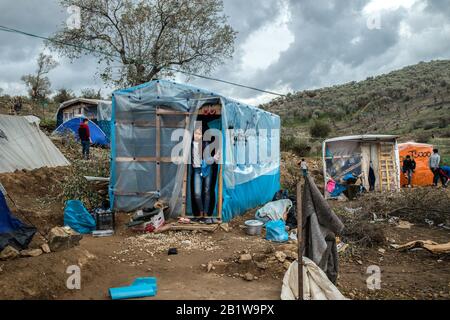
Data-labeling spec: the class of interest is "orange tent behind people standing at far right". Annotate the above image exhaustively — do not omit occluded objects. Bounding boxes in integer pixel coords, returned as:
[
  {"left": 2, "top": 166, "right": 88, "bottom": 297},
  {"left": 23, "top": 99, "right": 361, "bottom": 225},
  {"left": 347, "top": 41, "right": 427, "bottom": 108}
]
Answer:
[{"left": 398, "top": 142, "right": 433, "bottom": 186}]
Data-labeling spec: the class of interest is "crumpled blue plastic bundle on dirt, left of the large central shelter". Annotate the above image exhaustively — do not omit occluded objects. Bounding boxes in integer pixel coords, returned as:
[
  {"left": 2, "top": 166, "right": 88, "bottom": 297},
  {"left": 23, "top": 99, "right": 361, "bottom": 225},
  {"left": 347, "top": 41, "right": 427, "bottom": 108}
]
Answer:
[{"left": 64, "top": 200, "right": 96, "bottom": 234}]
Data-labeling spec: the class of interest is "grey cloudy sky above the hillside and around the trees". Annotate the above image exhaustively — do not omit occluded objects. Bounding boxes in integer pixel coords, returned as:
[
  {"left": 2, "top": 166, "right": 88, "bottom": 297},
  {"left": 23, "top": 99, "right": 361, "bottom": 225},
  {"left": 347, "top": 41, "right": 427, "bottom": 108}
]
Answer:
[{"left": 0, "top": 0, "right": 450, "bottom": 104}]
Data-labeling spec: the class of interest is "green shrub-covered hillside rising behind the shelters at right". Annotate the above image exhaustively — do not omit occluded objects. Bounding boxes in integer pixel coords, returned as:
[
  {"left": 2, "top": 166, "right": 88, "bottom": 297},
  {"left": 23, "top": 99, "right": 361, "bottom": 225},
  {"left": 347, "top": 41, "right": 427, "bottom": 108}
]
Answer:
[{"left": 262, "top": 60, "right": 450, "bottom": 160}]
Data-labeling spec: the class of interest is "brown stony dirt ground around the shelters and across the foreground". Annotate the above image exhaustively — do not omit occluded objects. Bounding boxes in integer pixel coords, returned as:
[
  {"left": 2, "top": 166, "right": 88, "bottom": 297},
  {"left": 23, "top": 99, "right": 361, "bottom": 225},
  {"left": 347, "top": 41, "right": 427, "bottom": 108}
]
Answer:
[{"left": 0, "top": 149, "right": 450, "bottom": 300}]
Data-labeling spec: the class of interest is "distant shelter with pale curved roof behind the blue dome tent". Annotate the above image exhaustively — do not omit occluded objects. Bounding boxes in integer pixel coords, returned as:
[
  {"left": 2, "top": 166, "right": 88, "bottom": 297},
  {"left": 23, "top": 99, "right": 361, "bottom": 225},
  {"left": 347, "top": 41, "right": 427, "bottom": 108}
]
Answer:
[{"left": 56, "top": 98, "right": 111, "bottom": 127}]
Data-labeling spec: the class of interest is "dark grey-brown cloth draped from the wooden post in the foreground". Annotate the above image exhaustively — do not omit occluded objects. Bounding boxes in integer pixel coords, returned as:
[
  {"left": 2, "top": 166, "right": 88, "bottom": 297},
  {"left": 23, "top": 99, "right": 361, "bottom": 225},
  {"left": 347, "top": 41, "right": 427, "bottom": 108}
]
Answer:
[{"left": 302, "top": 176, "right": 344, "bottom": 283}]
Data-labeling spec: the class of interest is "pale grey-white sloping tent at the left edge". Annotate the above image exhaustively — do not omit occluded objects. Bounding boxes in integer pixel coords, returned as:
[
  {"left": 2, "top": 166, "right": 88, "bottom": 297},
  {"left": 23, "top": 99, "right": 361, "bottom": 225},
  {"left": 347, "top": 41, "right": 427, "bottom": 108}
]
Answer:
[{"left": 0, "top": 115, "right": 70, "bottom": 173}]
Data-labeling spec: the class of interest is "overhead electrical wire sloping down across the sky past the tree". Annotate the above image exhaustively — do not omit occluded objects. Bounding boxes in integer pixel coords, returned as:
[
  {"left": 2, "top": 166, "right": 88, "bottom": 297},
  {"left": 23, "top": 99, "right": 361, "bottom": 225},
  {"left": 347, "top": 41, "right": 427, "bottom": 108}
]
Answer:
[{"left": 0, "top": 25, "right": 286, "bottom": 97}]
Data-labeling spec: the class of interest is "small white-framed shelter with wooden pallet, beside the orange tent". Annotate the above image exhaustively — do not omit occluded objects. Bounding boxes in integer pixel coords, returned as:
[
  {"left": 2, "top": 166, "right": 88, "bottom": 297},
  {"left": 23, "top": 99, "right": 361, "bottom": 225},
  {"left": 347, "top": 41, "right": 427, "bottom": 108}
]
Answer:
[{"left": 323, "top": 135, "right": 400, "bottom": 198}]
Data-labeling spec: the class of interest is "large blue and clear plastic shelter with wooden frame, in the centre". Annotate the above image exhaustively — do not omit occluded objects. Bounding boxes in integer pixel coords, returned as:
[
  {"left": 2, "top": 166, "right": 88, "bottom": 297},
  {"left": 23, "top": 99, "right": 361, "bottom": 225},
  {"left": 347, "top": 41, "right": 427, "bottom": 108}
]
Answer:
[{"left": 110, "top": 81, "right": 280, "bottom": 221}]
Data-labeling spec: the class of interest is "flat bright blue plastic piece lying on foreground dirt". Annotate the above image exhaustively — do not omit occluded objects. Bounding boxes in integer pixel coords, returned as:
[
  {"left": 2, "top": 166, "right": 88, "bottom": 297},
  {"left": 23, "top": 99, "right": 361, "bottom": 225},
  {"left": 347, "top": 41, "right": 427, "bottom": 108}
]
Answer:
[{"left": 109, "top": 278, "right": 158, "bottom": 300}]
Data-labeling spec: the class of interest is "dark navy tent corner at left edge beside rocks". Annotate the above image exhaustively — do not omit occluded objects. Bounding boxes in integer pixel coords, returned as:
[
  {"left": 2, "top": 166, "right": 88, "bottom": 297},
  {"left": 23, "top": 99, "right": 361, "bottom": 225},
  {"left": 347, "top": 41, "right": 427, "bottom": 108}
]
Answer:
[{"left": 0, "top": 191, "right": 36, "bottom": 251}]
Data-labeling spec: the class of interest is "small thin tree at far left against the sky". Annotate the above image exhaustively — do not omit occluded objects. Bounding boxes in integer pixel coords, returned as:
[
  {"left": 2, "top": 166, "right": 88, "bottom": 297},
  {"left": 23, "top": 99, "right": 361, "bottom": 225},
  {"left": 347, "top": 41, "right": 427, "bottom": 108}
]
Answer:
[{"left": 22, "top": 53, "right": 58, "bottom": 100}]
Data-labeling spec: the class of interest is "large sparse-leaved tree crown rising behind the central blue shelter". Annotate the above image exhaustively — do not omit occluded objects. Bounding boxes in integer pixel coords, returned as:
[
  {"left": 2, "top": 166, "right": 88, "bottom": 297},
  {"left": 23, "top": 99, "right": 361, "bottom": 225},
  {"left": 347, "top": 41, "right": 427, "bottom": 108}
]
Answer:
[{"left": 48, "top": 0, "right": 236, "bottom": 85}]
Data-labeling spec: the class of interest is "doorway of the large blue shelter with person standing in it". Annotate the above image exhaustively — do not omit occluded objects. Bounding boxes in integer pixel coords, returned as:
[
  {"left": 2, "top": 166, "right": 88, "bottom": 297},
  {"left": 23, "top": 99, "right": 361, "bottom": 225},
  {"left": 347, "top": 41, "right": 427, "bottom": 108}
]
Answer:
[{"left": 186, "top": 105, "right": 222, "bottom": 220}]
